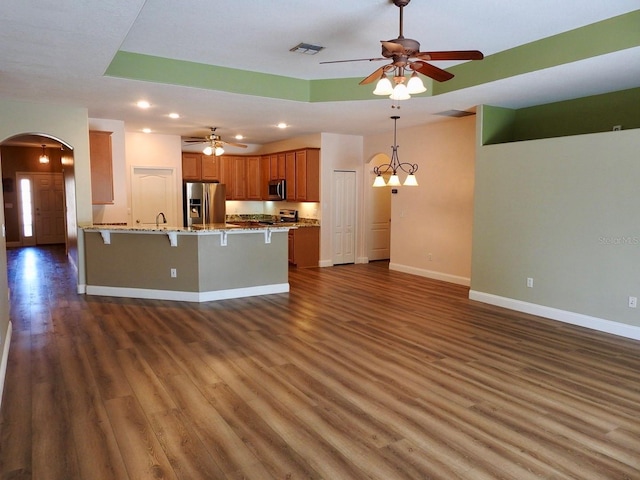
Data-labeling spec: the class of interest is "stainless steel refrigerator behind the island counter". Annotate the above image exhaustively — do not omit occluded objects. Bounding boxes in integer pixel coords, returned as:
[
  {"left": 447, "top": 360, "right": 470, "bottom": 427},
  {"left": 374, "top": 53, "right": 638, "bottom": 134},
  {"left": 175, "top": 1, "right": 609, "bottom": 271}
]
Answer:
[{"left": 182, "top": 182, "right": 227, "bottom": 227}]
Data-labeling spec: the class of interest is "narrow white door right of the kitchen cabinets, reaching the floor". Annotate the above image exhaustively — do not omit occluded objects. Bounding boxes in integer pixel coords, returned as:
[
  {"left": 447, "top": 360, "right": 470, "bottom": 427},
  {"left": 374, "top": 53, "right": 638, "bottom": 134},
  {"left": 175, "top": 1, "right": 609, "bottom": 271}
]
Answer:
[{"left": 332, "top": 171, "right": 356, "bottom": 265}]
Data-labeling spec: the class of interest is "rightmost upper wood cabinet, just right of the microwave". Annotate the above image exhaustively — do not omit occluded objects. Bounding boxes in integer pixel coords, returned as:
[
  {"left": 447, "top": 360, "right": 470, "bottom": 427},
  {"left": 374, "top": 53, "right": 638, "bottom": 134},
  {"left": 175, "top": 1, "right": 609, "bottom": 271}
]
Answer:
[{"left": 285, "top": 148, "right": 320, "bottom": 202}]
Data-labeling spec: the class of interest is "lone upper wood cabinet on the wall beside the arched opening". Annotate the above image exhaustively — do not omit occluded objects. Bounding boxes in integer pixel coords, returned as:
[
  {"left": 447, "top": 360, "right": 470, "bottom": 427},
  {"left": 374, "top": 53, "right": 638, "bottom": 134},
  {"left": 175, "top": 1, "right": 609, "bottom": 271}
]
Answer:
[{"left": 89, "top": 130, "right": 113, "bottom": 205}]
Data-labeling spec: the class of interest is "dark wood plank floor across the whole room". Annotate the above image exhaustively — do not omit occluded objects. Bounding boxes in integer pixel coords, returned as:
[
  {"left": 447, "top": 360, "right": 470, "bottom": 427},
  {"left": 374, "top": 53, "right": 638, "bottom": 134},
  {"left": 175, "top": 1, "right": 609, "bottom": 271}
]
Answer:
[{"left": 0, "top": 247, "right": 640, "bottom": 480}]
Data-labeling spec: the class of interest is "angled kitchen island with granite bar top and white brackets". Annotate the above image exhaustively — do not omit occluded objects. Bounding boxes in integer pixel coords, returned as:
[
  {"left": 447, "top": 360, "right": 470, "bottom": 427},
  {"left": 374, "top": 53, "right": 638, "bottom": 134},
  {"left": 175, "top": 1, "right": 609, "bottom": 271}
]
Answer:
[{"left": 82, "top": 224, "right": 289, "bottom": 302}]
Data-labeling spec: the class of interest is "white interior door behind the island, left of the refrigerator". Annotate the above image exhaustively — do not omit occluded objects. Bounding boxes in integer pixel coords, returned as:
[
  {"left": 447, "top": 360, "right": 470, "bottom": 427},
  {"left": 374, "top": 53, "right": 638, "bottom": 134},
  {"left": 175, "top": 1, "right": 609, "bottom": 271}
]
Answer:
[{"left": 131, "top": 167, "right": 176, "bottom": 226}]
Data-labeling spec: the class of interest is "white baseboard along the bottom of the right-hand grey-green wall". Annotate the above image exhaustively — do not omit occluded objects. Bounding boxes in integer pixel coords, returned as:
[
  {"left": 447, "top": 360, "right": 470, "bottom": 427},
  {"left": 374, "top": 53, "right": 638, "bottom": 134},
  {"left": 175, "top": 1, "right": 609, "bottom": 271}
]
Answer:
[{"left": 469, "top": 290, "right": 640, "bottom": 340}]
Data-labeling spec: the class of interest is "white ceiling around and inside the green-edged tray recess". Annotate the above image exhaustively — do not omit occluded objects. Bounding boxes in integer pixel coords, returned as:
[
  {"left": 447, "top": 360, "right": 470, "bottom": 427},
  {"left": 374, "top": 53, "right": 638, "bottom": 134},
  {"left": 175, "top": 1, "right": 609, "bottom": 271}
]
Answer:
[{"left": 0, "top": 0, "right": 640, "bottom": 148}]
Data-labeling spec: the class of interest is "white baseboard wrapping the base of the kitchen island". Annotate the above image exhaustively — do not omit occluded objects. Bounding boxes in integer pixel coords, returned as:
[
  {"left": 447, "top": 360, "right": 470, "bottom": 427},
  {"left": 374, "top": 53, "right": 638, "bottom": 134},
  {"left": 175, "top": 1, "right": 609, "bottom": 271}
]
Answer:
[{"left": 86, "top": 282, "right": 289, "bottom": 302}]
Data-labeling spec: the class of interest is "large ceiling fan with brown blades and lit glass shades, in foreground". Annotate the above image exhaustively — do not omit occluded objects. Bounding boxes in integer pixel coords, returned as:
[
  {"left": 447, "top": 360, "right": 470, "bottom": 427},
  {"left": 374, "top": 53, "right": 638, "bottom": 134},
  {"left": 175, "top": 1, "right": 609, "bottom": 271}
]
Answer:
[{"left": 320, "top": 0, "right": 484, "bottom": 100}]
